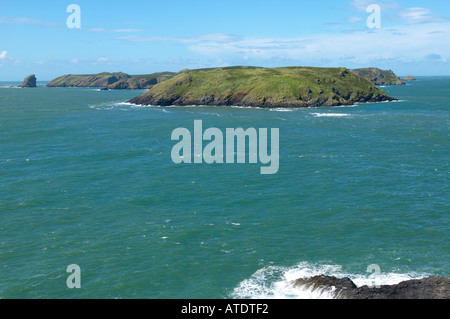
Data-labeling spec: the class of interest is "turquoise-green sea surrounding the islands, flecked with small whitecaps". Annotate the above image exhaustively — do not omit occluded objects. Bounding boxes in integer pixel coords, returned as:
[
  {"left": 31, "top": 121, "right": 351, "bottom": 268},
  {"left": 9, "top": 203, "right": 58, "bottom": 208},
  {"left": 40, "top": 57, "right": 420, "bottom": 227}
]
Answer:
[{"left": 0, "top": 77, "right": 450, "bottom": 299}]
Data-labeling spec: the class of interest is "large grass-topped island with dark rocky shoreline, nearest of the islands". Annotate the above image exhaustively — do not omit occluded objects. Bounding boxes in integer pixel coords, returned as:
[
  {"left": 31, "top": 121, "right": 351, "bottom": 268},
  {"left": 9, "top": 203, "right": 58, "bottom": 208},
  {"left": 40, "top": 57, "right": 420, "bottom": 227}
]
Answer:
[{"left": 130, "top": 67, "right": 393, "bottom": 108}]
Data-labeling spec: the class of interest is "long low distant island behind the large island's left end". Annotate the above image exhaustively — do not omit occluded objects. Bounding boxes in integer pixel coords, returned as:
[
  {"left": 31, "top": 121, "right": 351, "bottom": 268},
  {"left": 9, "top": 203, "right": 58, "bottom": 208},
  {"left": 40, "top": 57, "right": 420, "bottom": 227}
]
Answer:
[{"left": 47, "top": 72, "right": 175, "bottom": 90}]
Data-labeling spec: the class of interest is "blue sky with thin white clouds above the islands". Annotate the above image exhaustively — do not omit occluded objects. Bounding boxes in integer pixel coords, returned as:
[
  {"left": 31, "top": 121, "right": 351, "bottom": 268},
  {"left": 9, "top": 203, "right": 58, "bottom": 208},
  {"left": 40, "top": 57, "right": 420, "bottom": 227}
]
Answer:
[{"left": 0, "top": 0, "right": 450, "bottom": 81}]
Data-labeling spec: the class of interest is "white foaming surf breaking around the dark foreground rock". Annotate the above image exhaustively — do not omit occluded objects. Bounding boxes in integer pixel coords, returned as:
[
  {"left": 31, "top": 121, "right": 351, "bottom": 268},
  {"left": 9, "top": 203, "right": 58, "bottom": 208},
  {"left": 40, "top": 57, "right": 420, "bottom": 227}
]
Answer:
[{"left": 230, "top": 262, "right": 427, "bottom": 299}]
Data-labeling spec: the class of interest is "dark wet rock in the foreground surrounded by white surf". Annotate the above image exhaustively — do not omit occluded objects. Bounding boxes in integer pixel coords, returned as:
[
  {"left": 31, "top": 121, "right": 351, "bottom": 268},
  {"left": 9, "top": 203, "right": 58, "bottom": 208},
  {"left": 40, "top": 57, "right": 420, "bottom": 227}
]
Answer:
[{"left": 292, "top": 275, "right": 450, "bottom": 299}]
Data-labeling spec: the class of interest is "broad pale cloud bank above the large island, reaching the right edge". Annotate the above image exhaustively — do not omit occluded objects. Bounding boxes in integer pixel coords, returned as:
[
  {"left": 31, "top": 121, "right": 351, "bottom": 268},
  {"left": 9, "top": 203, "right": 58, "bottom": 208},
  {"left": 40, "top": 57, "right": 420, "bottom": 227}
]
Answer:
[{"left": 188, "top": 23, "right": 450, "bottom": 66}]
